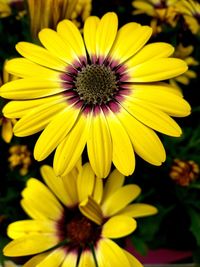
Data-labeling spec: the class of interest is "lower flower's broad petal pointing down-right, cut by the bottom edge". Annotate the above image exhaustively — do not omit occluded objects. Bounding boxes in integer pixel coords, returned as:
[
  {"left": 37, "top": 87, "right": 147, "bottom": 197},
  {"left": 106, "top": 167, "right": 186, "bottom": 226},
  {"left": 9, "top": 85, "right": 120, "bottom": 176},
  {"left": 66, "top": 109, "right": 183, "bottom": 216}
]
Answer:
[{"left": 95, "top": 238, "right": 132, "bottom": 267}]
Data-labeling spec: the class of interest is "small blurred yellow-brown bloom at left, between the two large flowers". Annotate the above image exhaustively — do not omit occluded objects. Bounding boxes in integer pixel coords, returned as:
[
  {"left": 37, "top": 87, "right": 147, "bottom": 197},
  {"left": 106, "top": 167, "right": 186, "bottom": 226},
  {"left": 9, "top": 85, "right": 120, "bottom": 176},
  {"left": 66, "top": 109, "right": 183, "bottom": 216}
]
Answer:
[{"left": 8, "top": 145, "right": 32, "bottom": 175}]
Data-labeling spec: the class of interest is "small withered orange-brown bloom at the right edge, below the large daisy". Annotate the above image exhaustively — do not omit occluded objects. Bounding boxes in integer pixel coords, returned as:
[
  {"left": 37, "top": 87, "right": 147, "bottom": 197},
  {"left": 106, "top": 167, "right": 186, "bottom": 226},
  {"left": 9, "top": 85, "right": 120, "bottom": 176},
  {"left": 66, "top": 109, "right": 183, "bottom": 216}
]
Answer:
[{"left": 169, "top": 159, "right": 200, "bottom": 186}]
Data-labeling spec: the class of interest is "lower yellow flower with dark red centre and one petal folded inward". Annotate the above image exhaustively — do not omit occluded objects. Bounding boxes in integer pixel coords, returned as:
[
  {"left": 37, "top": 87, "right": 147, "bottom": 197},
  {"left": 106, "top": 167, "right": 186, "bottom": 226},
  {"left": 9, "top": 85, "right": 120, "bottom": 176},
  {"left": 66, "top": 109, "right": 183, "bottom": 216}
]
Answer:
[{"left": 3, "top": 162, "right": 157, "bottom": 267}]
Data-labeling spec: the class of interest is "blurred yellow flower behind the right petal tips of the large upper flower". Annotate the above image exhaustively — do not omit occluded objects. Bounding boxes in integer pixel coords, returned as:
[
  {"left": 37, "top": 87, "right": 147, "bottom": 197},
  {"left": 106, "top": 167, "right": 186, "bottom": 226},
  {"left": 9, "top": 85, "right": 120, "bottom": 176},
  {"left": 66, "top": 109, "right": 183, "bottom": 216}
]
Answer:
[{"left": 170, "top": 44, "right": 199, "bottom": 87}]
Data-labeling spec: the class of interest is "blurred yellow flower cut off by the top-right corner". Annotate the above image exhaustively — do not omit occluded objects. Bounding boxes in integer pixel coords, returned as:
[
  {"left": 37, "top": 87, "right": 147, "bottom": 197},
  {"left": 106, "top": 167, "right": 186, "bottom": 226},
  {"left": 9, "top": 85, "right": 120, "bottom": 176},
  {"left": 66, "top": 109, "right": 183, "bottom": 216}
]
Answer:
[{"left": 176, "top": 0, "right": 200, "bottom": 34}]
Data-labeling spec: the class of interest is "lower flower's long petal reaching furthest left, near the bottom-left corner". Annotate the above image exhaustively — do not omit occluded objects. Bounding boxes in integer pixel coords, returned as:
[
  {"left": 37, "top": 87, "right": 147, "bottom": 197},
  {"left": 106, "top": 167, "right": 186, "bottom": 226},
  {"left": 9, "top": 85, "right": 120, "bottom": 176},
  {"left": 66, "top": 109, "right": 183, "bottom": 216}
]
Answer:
[{"left": 3, "top": 234, "right": 59, "bottom": 257}]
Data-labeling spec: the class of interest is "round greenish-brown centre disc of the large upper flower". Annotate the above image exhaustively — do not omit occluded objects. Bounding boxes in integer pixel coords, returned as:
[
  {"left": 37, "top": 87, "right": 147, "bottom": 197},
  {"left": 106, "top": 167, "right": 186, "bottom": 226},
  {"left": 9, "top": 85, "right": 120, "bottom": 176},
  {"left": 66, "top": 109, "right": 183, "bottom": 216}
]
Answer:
[{"left": 75, "top": 64, "right": 117, "bottom": 105}]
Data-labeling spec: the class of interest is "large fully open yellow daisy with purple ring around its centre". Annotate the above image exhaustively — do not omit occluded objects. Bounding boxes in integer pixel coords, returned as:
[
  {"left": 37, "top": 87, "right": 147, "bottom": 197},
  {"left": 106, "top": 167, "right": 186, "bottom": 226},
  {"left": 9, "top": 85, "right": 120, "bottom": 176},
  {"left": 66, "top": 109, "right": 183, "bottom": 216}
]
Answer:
[{"left": 0, "top": 12, "right": 190, "bottom": 180}]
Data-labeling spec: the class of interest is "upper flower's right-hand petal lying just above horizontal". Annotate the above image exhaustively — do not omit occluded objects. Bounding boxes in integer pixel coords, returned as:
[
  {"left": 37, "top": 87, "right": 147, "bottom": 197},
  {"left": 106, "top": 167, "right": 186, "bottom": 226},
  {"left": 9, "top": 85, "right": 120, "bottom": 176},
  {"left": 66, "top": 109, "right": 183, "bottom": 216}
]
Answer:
[{"left": 127, "top": 58, "right": 187, "bottom": 82}]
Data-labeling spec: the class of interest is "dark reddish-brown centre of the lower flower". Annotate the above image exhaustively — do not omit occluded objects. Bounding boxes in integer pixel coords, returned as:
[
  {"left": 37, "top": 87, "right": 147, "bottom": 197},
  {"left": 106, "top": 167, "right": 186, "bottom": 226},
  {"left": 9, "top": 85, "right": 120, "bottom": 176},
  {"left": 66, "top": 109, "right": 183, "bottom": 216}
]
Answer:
[{"left": 66, "top": 211, "right": 101, "bottom": 247}]
